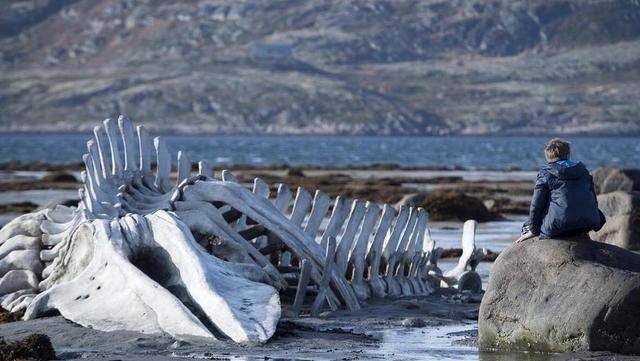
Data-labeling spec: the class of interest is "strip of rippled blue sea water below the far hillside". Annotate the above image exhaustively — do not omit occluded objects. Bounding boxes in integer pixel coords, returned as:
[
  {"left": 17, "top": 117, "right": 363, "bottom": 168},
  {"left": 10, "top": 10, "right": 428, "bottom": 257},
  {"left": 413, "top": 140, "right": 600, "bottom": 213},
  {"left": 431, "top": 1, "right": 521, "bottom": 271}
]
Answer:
[{"left": 0, "top": 133, "right": 640, "bottom": 169}]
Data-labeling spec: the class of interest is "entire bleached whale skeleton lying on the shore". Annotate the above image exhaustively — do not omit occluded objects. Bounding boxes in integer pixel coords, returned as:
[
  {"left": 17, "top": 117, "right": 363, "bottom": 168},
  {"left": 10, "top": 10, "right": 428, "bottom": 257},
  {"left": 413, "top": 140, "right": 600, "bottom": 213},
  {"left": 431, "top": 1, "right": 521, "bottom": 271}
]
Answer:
[{"left": 0, "top": 116, "right": 476, "bottom": 343}]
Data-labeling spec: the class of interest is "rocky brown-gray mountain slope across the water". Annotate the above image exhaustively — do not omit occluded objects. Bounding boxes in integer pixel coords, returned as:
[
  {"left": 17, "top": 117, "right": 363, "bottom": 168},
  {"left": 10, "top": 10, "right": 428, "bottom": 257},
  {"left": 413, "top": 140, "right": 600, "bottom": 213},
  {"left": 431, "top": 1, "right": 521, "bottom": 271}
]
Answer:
[{"left": 0, "top": 0, "right": 640, "bottom": 134}]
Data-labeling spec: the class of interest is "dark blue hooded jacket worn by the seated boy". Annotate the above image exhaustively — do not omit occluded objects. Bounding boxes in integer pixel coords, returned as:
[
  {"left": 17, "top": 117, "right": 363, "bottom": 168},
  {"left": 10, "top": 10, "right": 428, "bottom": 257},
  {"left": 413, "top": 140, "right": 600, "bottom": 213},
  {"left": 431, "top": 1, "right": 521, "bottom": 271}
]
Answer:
[{"left": 525, "top": 160, "right": 605, "bottom": 238}]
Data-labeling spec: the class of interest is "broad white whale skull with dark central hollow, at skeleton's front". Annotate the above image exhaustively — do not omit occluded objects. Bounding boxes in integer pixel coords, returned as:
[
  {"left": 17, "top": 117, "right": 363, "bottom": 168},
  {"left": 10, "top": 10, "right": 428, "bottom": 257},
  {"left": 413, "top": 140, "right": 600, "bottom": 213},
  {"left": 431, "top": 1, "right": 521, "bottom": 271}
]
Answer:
[{"left": 25, "top": 211, "right": 280, "bottom": 342}]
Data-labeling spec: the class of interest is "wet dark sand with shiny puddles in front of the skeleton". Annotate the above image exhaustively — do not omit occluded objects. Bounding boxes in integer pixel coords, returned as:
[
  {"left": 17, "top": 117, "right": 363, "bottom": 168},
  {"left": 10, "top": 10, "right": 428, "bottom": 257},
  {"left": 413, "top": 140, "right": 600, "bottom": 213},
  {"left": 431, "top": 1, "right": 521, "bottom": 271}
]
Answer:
[{"left": 0, "top": 296, "right": 637, "bottom": 361}]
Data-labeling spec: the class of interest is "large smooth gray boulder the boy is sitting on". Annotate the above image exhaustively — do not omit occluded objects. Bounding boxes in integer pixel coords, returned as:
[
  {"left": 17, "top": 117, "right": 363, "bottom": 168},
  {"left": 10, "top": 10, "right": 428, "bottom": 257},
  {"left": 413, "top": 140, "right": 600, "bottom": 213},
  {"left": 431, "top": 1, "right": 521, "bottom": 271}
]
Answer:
[{"left": 478, "top": 237, "right": 640, "bottom": 353}]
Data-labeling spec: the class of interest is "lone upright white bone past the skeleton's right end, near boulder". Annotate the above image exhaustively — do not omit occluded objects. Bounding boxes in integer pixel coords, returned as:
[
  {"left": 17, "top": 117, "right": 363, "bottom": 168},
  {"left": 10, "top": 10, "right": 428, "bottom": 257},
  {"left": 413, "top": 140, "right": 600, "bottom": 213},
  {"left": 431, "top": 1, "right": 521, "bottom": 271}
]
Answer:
[{"left": 429, "top": 219, "right": 487, "bottom": 292}]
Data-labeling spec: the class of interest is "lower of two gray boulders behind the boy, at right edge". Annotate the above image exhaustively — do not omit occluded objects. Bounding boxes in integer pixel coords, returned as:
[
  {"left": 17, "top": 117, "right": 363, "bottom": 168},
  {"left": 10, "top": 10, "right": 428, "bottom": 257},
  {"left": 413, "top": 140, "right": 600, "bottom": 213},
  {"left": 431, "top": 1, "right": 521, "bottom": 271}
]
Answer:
[{"left": 591, "top": 191, "right": 640, "bottom": 250}]
